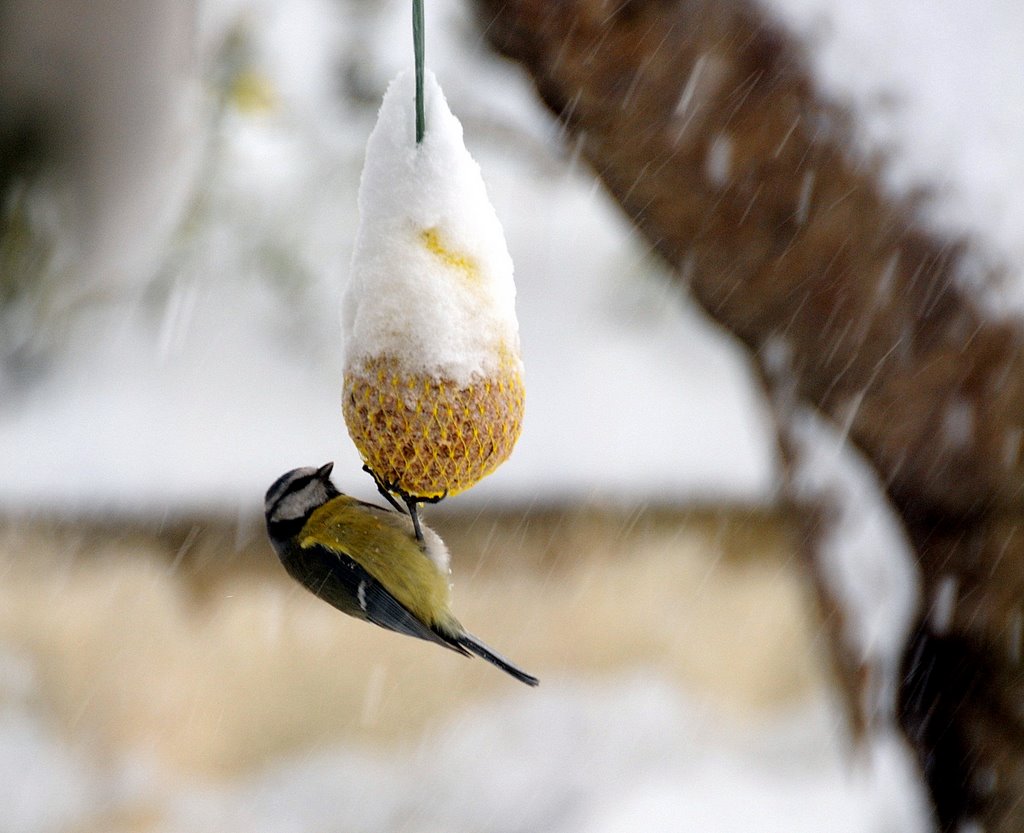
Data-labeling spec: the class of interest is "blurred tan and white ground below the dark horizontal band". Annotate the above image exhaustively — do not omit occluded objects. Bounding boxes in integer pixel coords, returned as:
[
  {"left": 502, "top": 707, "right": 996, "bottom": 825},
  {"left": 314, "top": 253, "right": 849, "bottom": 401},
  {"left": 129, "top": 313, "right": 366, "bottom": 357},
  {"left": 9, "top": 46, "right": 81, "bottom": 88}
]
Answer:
[{"left": 0, "top": 506, "right": 926, "bottom": 833}]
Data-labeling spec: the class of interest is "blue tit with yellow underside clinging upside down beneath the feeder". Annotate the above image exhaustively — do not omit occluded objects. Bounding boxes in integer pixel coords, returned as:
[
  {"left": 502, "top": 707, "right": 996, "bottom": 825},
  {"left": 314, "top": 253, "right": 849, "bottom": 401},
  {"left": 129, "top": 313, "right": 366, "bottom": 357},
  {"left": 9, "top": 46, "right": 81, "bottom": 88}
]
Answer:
[{"left": 264, "top": 463, "right": 539, "bottom": 685}]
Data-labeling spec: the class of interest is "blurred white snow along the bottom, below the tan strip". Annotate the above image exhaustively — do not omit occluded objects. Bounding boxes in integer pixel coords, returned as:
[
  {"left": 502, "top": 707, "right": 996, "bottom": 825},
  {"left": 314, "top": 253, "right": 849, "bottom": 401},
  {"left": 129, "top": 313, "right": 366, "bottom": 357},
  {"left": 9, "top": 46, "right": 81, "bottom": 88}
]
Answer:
[{"left": 0, "top": 663, "right": 924, "bottom": 833}]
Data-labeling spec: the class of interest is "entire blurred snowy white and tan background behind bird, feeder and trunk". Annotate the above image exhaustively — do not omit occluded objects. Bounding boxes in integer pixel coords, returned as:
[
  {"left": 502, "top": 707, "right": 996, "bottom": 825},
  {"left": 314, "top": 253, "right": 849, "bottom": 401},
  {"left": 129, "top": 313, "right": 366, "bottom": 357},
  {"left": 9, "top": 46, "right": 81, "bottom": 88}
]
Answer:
[{"left": 0, "top": 0, "right": 1024, "bottom": 833}]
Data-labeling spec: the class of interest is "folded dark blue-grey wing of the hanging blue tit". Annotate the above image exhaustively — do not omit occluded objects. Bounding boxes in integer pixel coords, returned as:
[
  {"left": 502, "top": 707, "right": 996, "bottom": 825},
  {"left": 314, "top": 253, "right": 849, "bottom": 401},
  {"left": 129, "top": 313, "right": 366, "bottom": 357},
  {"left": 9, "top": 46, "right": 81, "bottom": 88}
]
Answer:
[{"left": 294, "top": 544, "right": 468, "bottom": 655}]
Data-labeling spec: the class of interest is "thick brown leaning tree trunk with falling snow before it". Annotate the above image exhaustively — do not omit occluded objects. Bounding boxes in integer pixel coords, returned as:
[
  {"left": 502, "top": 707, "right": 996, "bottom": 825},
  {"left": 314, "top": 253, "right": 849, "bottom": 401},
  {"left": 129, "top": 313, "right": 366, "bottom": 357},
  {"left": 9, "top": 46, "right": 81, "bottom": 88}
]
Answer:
[{"left": 473, "top": 0, "right": 1024, "bottom": 831}]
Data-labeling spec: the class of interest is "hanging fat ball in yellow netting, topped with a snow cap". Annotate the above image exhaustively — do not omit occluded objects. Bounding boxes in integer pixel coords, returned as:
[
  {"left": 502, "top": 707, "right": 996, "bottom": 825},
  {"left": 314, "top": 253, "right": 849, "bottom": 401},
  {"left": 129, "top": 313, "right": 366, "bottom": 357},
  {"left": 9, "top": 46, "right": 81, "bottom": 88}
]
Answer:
[{"left": 342, "top": 72, "right": 524, "bottom": 499}]
